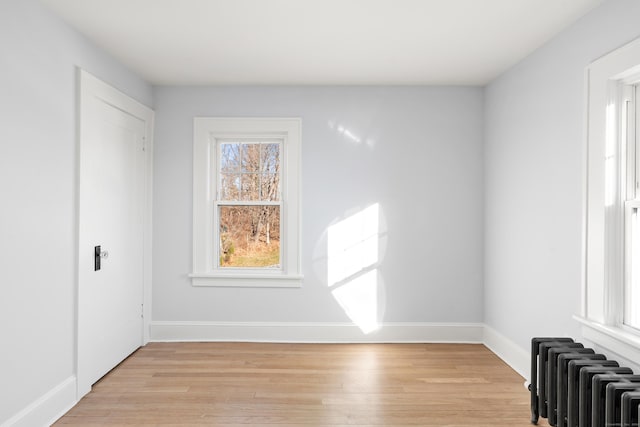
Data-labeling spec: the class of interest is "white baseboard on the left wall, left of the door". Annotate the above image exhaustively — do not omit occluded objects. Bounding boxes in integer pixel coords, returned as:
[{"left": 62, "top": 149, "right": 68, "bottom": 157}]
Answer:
[{"left": 0, "top": 375, "right": 77, "bottom": 427}]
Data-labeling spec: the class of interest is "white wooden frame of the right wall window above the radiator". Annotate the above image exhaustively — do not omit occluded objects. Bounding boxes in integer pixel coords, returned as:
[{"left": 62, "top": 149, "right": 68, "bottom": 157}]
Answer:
[{"left": 576, "top": 39, "right": 640, "bottom": 361}]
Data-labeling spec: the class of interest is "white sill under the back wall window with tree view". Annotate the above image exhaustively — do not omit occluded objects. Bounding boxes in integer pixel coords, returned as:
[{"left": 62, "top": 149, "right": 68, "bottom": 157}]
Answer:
[{"left": 189, "top": 273, "right": 304, "bottom": 288}]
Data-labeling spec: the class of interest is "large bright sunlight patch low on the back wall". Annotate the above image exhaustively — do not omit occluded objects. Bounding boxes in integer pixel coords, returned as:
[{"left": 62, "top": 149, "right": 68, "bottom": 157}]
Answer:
[{"left": 314, "top": 203, "right": 386, "bottom": 335}]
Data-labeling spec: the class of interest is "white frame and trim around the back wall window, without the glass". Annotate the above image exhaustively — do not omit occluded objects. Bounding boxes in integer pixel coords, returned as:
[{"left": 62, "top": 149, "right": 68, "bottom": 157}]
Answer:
[{"left": 189, "top": 117, "right": 303, "bottom": 287}]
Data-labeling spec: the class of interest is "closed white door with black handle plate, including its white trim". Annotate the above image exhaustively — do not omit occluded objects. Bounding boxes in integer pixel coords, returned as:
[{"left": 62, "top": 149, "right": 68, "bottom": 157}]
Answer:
[{"left": 77, "top": 72, "right": 148, "bottom": 397}]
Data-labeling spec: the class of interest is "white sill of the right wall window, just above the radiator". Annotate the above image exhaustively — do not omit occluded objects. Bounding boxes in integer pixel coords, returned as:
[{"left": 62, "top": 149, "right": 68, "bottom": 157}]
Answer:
[{"left": 574, "top": 316, "right": 640, "bottom": 363}]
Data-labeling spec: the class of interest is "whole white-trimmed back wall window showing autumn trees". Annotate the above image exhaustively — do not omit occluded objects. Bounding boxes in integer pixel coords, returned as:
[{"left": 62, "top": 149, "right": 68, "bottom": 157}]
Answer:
[{"left": 190, "top": 117, "right": 302, "bottom": 287}]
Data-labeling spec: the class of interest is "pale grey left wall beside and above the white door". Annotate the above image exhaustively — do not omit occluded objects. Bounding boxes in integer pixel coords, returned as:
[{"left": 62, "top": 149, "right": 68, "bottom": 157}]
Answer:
[{"left": 0, "top": 0, "right": 153, "bottom": 425}]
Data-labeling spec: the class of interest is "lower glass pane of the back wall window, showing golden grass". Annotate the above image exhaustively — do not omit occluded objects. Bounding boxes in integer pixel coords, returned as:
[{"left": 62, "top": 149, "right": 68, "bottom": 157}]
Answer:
[{"left": 219, "top": 205, "right": 280, "bottom": 268}]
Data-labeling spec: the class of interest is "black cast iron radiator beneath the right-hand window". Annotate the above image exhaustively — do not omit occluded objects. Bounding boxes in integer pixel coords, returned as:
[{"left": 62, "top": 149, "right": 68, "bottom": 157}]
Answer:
[{"left": 529, "top": 337, "right": 640, "bottom": 427}]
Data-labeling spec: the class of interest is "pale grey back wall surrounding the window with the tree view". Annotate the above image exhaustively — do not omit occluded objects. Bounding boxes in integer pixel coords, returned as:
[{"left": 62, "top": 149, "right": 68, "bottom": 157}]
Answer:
[{"left": 153, "top": 87, "right": 483, "bottom": 332}]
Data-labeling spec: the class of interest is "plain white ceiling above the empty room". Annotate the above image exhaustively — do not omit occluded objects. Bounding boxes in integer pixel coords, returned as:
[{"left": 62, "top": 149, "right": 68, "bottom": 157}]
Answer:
[{"left": 41, "top": 0, "right": 603, "bottom": 85}]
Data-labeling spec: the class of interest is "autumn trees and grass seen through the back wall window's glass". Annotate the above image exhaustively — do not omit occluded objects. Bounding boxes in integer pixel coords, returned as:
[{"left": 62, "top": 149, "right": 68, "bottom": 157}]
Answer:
[{"left": 218, "top": 141, "right": 281, "bottom": 268}]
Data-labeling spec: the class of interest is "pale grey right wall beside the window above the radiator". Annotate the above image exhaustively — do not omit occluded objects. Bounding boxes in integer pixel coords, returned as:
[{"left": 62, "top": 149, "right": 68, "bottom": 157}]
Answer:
[{"left": 484, "top": 0, "right": 640, "bottom": 362}]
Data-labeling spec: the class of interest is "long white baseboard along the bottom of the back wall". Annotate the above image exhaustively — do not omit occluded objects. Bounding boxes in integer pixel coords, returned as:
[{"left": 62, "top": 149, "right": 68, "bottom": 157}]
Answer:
[{"left": 150, "top": 322, "right": 483, "bottom": 343}]
